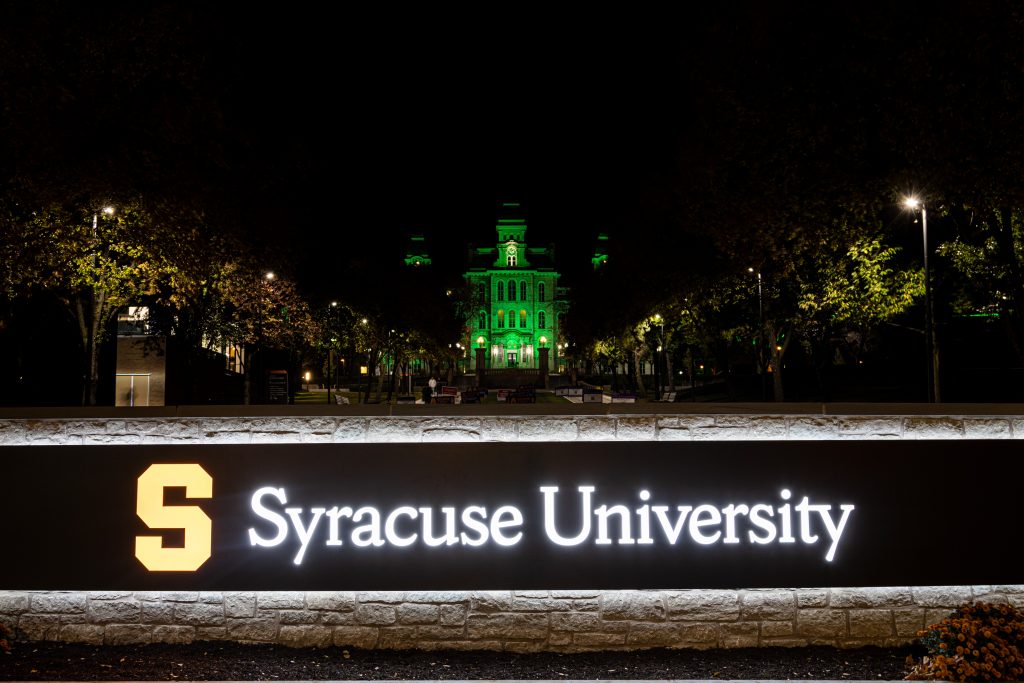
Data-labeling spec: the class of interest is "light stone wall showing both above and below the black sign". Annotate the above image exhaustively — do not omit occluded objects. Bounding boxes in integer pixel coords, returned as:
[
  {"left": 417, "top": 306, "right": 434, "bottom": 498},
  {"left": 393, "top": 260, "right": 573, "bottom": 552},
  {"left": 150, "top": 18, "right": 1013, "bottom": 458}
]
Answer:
[{"left": 0, "top": 407, "right": 1024, "bottom": 651}]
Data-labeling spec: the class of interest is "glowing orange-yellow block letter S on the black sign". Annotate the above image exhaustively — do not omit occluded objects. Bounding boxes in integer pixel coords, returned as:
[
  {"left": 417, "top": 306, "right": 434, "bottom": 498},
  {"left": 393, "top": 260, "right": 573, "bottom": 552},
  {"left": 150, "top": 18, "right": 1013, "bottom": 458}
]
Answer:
[{"left": 135, "top": 464, "right": 213, "bottom": 571}]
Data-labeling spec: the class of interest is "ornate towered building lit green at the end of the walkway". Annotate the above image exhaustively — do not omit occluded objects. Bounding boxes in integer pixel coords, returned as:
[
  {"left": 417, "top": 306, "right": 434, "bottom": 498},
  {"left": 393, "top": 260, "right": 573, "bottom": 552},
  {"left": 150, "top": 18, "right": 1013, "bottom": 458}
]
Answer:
[{"left": 465, "top": 203, "right": 566, "bottom": 372}]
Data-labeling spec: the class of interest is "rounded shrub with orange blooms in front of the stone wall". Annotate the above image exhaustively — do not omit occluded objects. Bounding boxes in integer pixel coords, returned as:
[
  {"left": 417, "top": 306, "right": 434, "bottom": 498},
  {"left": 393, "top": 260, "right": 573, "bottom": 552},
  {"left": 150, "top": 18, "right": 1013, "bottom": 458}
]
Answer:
[{"left": 907, "top": 602, "right": 1024, "bottom": 681}]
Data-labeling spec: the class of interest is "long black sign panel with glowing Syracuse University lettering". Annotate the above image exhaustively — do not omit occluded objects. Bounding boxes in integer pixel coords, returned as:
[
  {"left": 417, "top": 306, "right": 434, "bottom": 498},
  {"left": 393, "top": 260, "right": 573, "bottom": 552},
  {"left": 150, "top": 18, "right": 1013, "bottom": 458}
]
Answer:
[{"left": 0, "top": 441, "right": 1022, "bottom": 590}]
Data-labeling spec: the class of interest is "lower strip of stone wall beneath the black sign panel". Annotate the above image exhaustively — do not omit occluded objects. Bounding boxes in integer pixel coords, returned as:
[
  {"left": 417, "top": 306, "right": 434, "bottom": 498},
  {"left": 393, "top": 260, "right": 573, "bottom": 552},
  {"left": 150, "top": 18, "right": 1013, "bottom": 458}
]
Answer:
[{"left": 0, "top": 586, "right": 1024, "bottom": 651}]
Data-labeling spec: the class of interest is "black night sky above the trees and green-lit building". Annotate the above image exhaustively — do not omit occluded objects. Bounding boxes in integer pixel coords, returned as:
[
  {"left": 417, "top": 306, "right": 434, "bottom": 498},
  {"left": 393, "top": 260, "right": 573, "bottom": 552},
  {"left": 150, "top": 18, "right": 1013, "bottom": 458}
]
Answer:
[{"left": 0, "top": 2, "right": 1020, "bottom": 296}]
